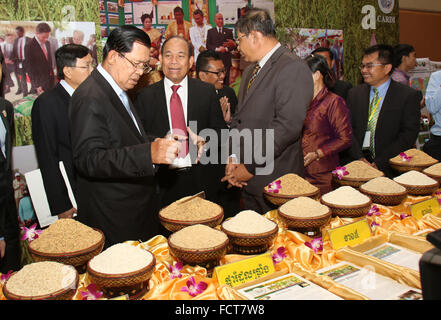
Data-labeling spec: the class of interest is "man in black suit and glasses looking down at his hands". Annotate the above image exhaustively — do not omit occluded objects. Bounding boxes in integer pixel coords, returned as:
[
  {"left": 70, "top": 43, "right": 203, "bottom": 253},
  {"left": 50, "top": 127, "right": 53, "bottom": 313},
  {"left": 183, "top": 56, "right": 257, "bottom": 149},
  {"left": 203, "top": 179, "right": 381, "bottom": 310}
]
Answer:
[{"left": 69, "top": 26, "right": 180, "bottom": 248}]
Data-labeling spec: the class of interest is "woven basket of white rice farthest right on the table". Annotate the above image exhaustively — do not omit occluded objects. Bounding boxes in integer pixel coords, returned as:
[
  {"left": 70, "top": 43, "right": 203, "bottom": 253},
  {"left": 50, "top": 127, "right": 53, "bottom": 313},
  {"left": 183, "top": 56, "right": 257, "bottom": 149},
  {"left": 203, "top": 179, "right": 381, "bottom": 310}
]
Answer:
[{"left": 394, "top": 170, "right": 439, "bottom": 196}]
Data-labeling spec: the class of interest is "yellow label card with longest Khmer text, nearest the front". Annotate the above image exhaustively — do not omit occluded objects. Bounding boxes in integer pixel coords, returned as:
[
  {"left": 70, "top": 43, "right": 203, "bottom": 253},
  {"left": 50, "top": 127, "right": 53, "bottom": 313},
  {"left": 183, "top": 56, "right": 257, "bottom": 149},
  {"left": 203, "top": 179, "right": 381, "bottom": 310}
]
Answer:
[{"left": 213, "top": 253, "right": 275, "bottom": 288}]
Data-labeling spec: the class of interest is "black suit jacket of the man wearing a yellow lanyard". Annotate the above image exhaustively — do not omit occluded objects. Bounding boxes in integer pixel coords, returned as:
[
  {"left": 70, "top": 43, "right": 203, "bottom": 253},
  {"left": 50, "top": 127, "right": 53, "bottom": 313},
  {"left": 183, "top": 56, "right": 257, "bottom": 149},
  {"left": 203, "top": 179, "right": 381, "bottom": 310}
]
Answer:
[{"left": 347, "top": 80, "right": 421, "bottom": 176}]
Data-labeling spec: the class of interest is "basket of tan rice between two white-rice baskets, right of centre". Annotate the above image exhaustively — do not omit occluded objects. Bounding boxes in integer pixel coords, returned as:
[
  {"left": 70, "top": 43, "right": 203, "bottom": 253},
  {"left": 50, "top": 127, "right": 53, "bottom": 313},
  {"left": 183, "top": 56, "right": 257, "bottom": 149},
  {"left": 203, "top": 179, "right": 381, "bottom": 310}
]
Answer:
[{"left": 360, "top": 177, "right": 407, "bottom": 206}]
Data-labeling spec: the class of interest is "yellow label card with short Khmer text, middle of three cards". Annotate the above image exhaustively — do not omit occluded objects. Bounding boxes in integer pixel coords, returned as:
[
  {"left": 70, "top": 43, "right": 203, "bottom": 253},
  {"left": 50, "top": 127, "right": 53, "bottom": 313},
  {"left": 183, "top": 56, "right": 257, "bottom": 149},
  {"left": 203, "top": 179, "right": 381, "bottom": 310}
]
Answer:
[{"left": 328, "top": 219, "right": 372, "bottom": 250}]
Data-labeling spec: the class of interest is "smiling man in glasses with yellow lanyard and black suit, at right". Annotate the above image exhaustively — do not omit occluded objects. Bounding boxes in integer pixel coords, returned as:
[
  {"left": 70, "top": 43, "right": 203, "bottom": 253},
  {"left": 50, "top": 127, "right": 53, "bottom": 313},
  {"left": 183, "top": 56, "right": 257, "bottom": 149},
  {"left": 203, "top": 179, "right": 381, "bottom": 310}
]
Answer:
[{"left": 343, "top": 44, "right": 421, "bottom": 177}]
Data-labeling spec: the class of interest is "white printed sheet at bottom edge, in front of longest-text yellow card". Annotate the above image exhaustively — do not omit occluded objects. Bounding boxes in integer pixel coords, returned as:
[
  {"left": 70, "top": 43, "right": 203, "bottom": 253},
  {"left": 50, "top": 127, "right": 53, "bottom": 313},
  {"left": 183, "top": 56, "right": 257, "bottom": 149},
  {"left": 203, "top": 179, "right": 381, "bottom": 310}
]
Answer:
[{"left": 237, "top": 273, "right": 343, "bottom": 300}]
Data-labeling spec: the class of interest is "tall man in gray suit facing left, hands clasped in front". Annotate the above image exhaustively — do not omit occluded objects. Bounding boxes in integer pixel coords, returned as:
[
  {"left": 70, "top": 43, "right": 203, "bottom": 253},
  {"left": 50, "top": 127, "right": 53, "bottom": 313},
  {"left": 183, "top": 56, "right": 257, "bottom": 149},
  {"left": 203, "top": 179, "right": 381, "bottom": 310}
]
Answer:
[{"left": 222, "top": 8, "right": 313, "bottom": 213}]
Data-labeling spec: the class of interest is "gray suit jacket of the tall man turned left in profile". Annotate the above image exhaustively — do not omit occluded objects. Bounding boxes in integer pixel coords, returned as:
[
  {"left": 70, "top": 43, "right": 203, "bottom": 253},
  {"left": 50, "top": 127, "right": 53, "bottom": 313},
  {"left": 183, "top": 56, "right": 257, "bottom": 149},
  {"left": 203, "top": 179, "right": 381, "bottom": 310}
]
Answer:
[{"left": 230, "top": 47, "right": 313, "bottom": 196}]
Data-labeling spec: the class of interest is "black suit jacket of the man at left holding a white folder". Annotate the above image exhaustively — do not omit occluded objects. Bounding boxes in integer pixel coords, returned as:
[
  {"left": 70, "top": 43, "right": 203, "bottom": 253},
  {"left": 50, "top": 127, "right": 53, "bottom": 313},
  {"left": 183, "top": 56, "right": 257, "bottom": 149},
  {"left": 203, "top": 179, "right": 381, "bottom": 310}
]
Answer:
[{"left": 32, "top": 83, "right": 75, "bottom": 215}]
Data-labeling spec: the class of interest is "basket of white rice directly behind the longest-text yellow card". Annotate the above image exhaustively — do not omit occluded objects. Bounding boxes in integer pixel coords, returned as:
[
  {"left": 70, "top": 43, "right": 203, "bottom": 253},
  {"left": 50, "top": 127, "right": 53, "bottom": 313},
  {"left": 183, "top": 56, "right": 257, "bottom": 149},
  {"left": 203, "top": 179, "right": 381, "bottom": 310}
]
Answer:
[{"left": 221, "top": 210, "right": 279, "bottom": 254}]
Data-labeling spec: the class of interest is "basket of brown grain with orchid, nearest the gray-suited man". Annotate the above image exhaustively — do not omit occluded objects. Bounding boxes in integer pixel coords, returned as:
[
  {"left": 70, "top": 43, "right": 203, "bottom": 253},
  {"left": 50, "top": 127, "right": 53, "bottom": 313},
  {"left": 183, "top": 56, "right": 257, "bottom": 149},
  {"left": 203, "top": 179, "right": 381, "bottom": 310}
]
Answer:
[{"left": 263, "top": 173, "right": 320, "bottom": 206}]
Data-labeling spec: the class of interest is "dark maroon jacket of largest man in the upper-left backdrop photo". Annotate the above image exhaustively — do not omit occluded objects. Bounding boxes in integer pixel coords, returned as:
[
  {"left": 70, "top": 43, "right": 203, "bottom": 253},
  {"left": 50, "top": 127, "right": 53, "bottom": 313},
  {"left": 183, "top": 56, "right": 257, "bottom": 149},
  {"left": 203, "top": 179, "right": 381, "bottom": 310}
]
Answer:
[{"left": 25, "top": 38, "right": 55, "bottom": 91}]
